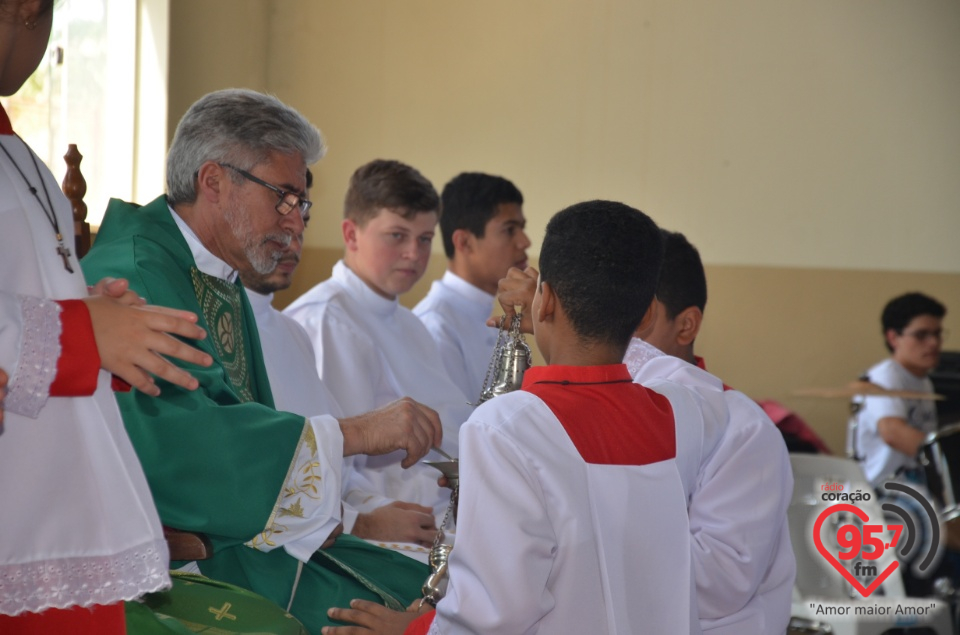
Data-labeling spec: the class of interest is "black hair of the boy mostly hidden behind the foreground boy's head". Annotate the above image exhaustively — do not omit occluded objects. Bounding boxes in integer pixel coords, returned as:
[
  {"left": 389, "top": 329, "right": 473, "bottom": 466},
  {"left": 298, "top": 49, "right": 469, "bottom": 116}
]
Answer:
[{"left": 657, "top": 229, "right": 707, "bottom": 320}]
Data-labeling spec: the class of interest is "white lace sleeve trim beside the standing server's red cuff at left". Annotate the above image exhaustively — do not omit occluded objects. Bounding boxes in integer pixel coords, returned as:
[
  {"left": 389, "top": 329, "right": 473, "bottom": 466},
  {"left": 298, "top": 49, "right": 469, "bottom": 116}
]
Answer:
[{"left": 3, "top": 295, "right": 61, "bottom": 419}]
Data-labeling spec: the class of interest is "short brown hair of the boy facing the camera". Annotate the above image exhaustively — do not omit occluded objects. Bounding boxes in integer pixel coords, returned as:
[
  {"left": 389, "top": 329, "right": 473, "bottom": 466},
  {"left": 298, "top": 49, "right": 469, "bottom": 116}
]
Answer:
[{"left": 343, "top": 159, "right": 440, "bottom": 227}]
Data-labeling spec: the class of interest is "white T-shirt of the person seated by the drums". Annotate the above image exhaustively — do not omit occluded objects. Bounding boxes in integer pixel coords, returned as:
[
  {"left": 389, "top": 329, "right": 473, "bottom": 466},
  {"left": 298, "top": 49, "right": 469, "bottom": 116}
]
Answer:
[{"left": 854, "top": 357, "right": 937, "bottom": 487}]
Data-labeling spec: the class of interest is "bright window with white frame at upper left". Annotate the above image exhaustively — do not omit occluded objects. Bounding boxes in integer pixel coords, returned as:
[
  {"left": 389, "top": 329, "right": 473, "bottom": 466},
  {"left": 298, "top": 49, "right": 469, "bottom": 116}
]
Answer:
[{"left": 4, "top": 0, "right": 169, "bottom": 226}]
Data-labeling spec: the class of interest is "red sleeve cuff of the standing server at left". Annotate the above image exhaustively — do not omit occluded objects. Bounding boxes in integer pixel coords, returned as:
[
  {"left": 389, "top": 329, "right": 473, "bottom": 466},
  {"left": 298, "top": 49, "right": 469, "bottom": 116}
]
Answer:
[{"left": 50, "top": 300, "right": 100, "bottom": 397}]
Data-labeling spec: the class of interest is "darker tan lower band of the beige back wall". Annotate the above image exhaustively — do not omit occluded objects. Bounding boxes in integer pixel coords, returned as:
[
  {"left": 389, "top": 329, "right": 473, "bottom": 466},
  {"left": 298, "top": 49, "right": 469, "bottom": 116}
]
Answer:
[{"left": 275, "top": 248, "right": 960, "bottom": 453}]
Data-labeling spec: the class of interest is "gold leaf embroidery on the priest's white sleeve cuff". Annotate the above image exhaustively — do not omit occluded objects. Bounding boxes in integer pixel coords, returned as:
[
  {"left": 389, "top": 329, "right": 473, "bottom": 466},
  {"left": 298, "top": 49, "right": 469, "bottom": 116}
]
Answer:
[{"left": 246, "top": 421, "right": 323, "bottom": 551}]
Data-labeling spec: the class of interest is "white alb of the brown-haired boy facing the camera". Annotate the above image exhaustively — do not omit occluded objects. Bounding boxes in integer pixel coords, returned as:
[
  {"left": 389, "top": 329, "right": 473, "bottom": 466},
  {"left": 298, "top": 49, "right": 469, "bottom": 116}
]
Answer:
[{"left": 284, "top": 261, "right": 472, "bottom": 515}]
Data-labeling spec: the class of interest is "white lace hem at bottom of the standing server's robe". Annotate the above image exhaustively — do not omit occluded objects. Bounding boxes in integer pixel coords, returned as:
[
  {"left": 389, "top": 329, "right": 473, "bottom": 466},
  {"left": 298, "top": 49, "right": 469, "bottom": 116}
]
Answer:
[{"left": 0, "top": 539, "right": 170, "bottom": 615}]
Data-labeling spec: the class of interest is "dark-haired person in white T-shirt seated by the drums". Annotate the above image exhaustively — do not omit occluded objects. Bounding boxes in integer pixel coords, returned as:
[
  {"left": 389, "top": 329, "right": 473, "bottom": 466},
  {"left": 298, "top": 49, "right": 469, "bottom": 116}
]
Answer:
[{"left": 855, "top": 293, "right": 947, "bottom": 487}]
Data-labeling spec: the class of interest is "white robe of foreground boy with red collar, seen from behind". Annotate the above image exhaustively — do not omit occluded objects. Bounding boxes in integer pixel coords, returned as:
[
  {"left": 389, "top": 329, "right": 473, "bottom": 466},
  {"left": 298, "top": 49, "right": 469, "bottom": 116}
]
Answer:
[{"left": 430, "top": 366, "right": 700, "bottom": 635}]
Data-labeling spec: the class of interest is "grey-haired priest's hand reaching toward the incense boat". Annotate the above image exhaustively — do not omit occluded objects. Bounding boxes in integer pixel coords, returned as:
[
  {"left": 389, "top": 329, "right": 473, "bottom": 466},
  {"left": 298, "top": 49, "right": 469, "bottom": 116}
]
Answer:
[{"left": 340, "top": 397, "right": 443, "bottom": 468}]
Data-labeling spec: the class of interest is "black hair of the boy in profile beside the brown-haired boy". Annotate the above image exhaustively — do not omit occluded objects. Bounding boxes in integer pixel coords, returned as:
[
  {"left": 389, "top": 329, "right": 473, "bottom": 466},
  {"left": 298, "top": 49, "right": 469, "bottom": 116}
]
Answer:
[{"left": 440, "top": 172, "right": 523, "bottom": 259}]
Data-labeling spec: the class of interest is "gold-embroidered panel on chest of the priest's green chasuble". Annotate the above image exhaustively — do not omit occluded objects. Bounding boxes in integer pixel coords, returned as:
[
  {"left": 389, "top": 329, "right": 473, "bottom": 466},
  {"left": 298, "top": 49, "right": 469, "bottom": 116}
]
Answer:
[{"left": 190, "top": 267, "right": 253, "bottom": 402}]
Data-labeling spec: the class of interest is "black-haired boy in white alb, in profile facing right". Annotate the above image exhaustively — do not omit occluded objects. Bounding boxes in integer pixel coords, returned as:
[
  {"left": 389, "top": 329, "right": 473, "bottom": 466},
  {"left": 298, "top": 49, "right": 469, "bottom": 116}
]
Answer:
[{"left": 413, "top": 172, "right": 530, "bottom": 401}]
